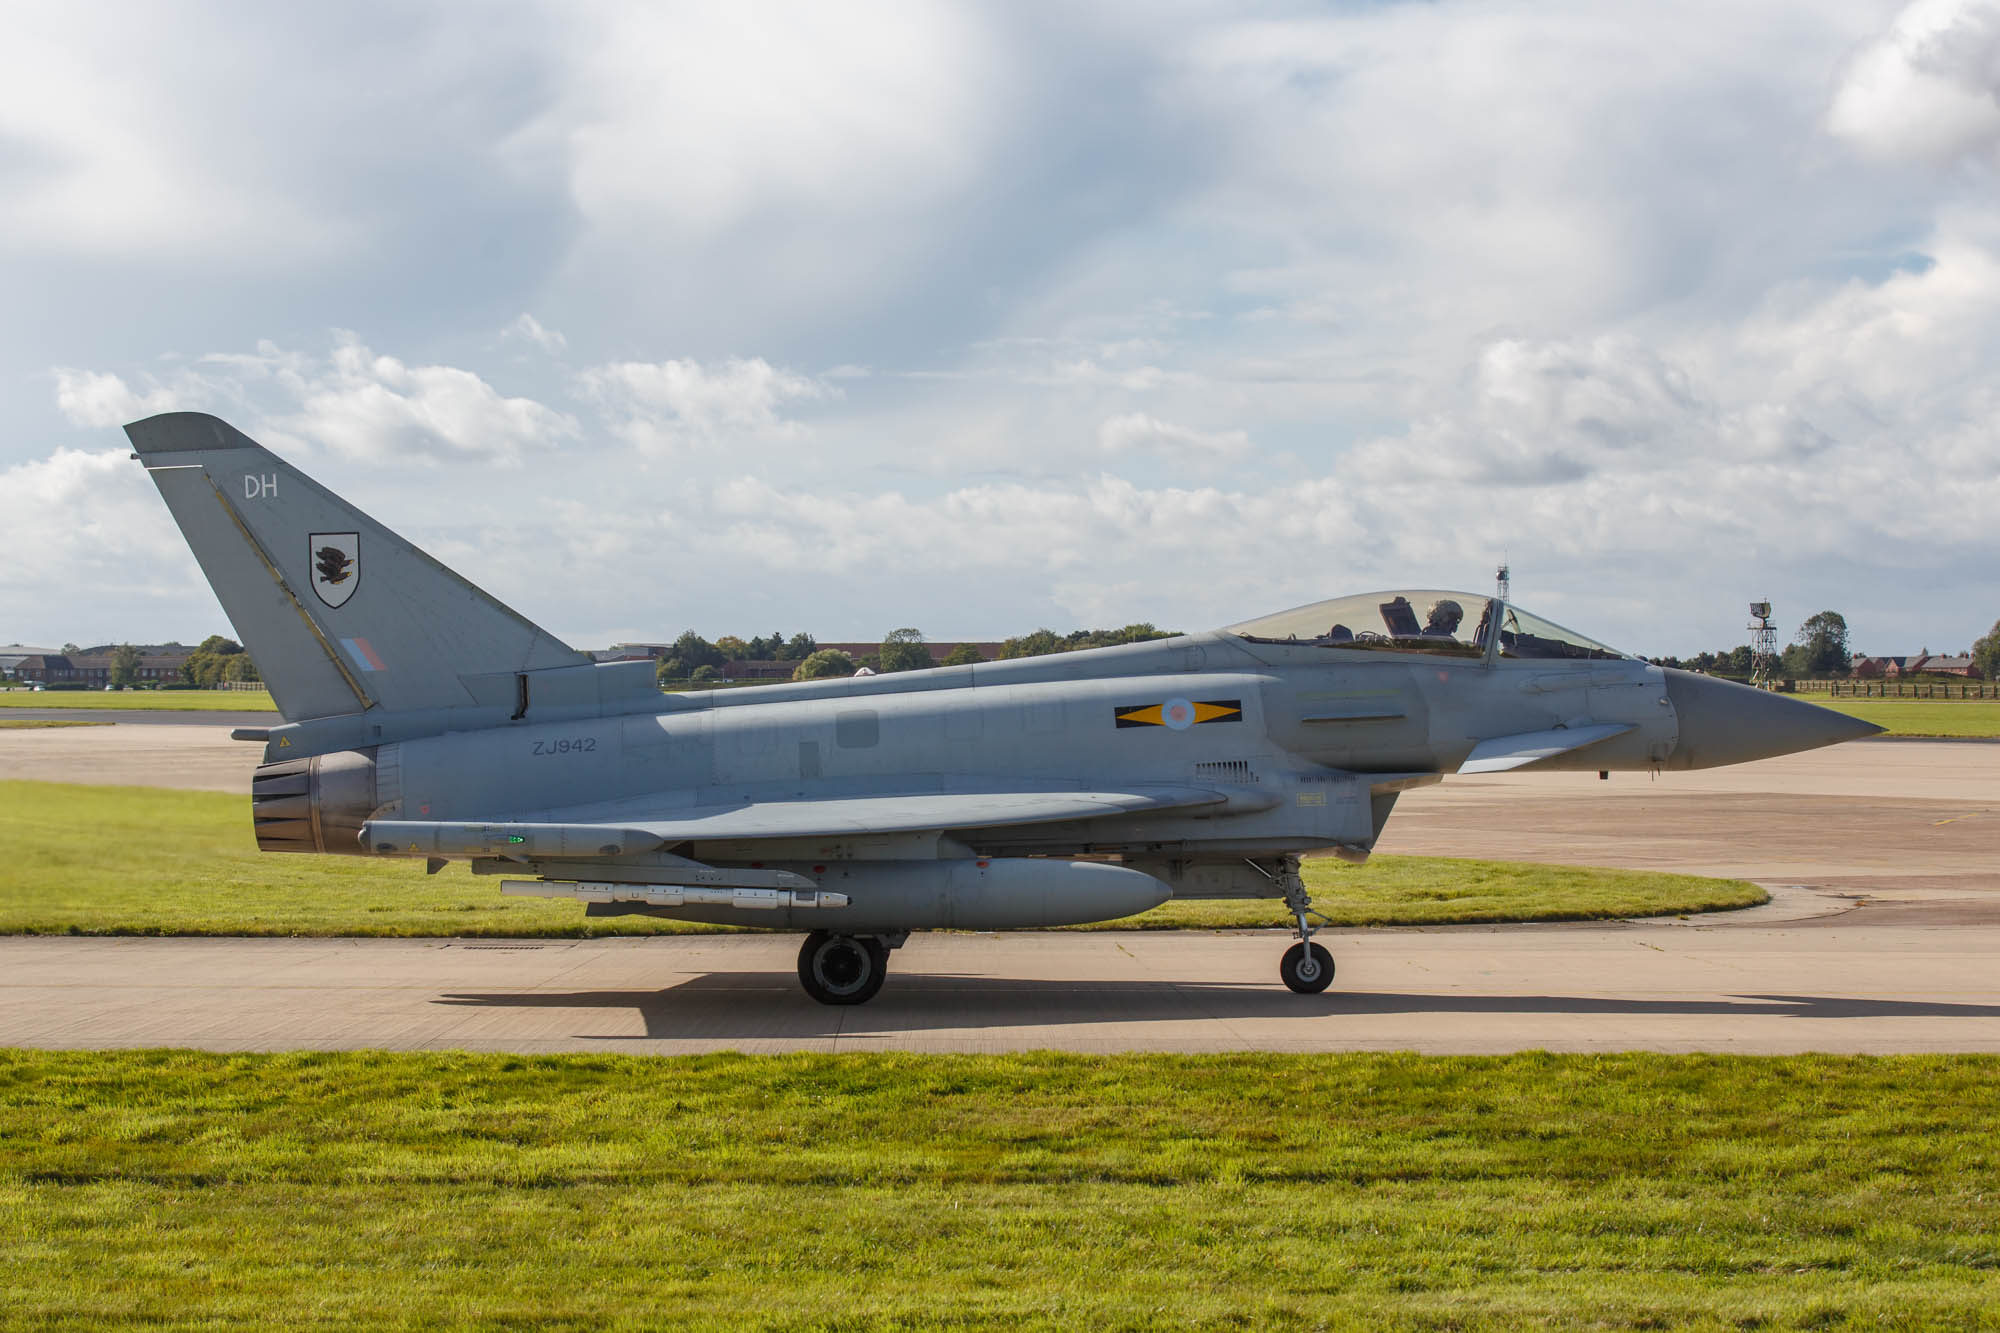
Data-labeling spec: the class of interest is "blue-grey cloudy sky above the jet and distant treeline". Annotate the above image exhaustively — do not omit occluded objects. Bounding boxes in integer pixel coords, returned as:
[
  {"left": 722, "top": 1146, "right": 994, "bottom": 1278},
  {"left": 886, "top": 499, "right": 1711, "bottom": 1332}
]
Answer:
[{"left": 0, "top": 0, "right": 2000, "bottom": 652}]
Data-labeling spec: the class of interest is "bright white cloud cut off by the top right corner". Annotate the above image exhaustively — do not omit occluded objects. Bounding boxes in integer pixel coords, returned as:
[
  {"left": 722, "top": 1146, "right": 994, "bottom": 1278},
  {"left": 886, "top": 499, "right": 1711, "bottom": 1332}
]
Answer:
[{"left": 1826, "top": 0, "right": 2000, "bottom": 164}]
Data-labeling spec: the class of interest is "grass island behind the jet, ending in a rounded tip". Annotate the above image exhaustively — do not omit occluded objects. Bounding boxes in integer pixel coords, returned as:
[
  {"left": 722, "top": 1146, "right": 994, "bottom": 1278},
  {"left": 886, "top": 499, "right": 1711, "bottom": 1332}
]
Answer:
[{"left": 0, "top": 783, "right": 1766, "bottom": 935}]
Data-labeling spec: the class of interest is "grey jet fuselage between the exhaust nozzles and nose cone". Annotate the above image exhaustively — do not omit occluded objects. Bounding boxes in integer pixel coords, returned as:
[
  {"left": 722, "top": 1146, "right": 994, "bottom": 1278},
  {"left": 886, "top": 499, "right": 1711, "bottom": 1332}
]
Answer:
[{"left": 286, "top": 632, "right": 1676, "bottom": 861}]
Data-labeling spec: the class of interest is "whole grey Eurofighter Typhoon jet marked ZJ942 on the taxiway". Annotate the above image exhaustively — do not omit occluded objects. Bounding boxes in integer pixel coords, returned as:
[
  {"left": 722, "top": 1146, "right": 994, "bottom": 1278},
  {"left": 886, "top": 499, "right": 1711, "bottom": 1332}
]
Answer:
[{"left": 126, "top": 412, "right": 1878, "bottom": 1005}]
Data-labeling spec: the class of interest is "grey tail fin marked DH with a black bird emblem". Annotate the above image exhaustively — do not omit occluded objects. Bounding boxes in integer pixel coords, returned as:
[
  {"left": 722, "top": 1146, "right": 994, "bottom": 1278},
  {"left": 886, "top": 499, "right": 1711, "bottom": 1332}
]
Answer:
[{"left": 126, "top": 412, "right": 590, "bottom": 723}]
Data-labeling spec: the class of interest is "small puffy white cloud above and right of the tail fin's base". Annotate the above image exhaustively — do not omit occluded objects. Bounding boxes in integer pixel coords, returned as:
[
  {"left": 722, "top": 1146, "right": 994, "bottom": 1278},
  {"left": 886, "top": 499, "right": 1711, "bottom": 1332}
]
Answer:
[{"left": 578, "top": 356, "right": 836, "bottom": 452}]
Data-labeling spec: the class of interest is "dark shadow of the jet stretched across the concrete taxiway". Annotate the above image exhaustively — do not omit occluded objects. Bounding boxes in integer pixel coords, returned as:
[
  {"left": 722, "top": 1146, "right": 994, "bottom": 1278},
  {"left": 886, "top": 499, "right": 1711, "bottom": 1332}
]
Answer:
[{"left": 434, "top": 973, "right": 2000, "bottom": 1041}]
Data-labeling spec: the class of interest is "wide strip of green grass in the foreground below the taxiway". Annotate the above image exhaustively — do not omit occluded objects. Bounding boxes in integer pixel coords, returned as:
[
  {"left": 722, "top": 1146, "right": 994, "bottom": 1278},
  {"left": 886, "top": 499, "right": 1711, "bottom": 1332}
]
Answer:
[{"left": 0, "top": 1053, "right": 2000, "bottom": 1329}]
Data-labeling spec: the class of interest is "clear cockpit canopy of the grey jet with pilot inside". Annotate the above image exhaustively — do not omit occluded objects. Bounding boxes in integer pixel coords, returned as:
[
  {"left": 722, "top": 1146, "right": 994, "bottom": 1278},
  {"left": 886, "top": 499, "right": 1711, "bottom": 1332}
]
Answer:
[{"left": 1224, "top": 590, "right": 1626, "bottom": 658}]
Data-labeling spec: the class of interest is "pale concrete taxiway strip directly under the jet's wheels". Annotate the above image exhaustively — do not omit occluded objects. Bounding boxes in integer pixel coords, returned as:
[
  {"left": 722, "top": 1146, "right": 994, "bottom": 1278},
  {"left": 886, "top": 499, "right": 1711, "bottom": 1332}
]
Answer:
[{"left": 0, "top": 893, "right": 2000, "bottom": 1055}]
